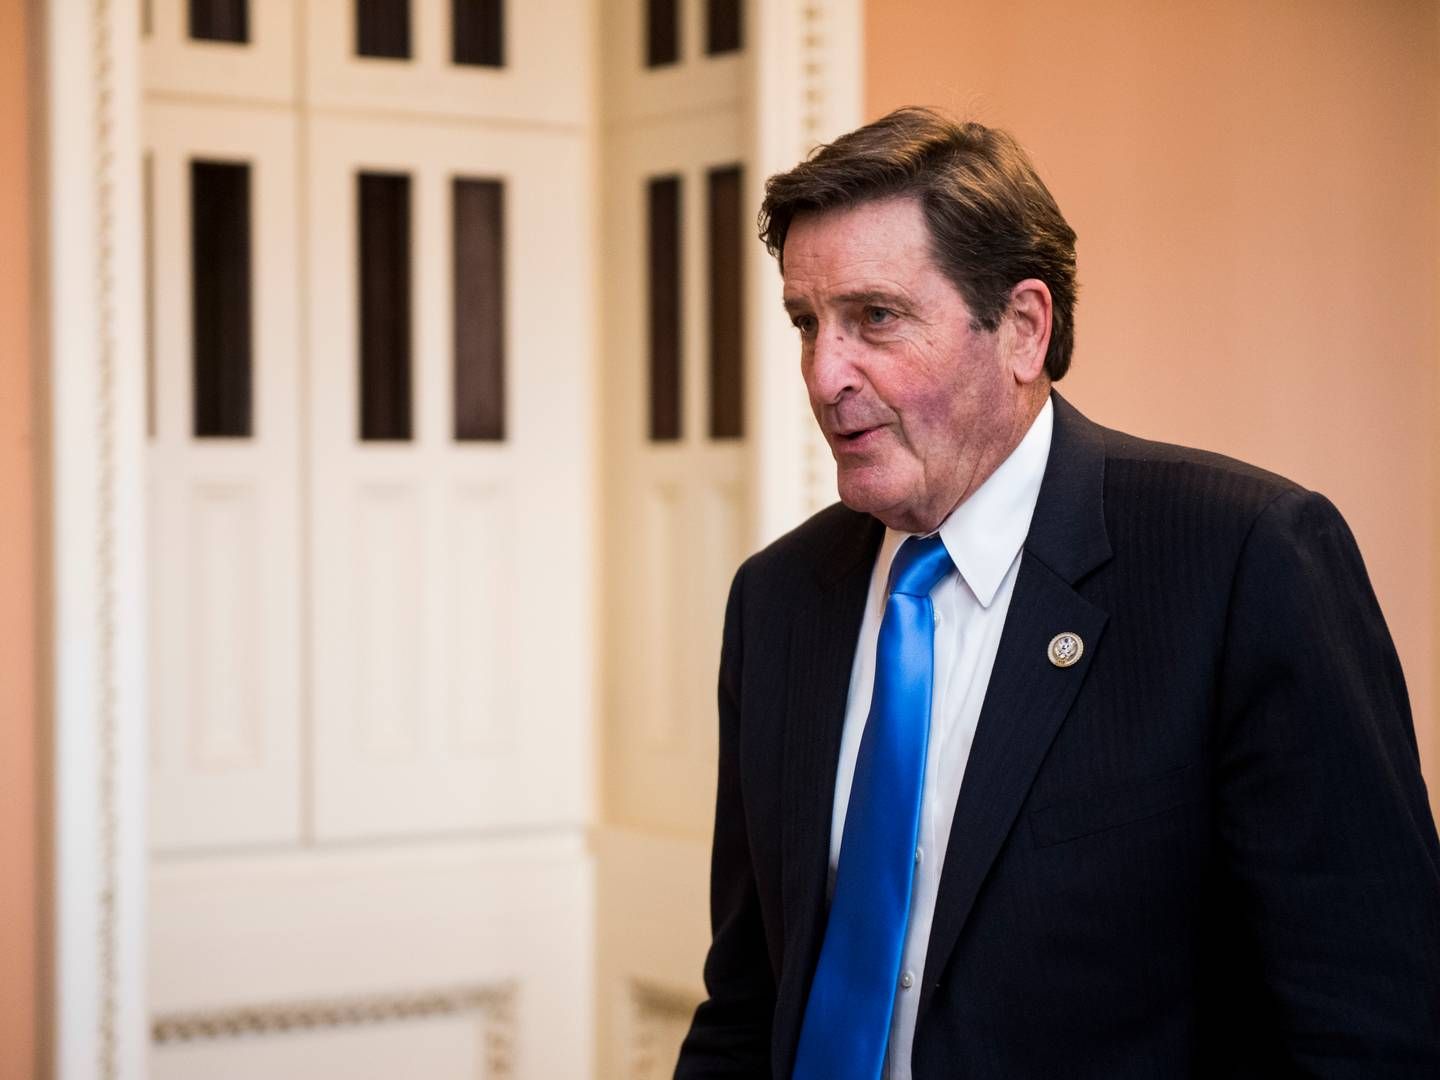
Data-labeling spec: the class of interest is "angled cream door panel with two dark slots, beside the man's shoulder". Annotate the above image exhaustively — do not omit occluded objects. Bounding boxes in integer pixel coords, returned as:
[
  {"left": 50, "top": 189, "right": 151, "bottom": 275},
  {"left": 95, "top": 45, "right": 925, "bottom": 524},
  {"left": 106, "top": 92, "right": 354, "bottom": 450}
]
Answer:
[{"left": 605, "top": 109, "right": 752, "bottom": 838}]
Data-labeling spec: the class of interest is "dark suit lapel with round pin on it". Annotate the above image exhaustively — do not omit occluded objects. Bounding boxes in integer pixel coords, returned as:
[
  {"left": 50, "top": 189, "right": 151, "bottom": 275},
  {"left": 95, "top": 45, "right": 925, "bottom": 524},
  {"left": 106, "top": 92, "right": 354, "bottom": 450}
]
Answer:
[{"left": 920, "top": 395, "right": 1110, "bottom": 1017}]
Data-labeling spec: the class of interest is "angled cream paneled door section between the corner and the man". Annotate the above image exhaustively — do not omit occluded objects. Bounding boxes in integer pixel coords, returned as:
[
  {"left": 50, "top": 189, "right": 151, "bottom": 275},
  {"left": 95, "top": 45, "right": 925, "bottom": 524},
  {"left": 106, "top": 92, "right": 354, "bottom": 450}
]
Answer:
[{"left": 598, "top": 0, "right": 773, "bottom": 1080}]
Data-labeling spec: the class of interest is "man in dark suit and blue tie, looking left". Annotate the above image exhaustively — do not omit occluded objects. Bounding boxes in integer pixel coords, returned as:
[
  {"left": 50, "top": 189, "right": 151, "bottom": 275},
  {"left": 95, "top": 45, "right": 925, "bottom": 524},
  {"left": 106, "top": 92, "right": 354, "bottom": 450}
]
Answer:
[{"left": 677, "top": 109, "right": 1440, "bottom": 1080}]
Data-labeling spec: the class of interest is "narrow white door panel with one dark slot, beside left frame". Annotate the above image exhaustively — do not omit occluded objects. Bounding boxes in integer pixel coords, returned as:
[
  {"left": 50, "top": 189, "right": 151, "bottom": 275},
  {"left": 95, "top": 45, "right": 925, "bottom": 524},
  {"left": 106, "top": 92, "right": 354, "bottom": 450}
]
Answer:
[{"left": 145, "top": 102, "right": 302, "bottom": 851}]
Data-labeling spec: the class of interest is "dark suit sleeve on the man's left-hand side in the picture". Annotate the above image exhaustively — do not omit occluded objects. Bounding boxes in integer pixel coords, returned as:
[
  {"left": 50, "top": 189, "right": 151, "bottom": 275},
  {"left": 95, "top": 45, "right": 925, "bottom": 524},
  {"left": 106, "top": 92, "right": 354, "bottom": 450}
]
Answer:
[{"left": 675, "top": 566, "right": 775, "bottom": 1080}]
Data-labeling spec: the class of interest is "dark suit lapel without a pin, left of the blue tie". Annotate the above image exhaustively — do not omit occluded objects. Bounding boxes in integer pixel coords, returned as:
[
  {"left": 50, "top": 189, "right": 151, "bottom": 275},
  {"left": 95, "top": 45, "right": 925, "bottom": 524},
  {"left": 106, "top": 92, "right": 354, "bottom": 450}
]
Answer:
[{"left": 775, "top": 514, "right": 884, "bottom": 1077}]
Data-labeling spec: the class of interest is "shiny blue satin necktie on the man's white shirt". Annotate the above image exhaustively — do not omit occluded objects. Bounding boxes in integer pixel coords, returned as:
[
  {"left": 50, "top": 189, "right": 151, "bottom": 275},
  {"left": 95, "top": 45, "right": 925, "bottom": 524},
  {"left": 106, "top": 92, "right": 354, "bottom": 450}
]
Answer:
[{"left": 792, "top": 536, "right": 953, "bottom": 1080}]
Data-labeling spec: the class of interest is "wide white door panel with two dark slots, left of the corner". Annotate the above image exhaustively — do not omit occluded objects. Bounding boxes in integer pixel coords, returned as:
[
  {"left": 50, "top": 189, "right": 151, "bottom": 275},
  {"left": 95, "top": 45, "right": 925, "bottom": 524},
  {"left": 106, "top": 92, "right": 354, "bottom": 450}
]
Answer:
[{"left": 310, "top": 117, "right": 590, "bottom": 838}]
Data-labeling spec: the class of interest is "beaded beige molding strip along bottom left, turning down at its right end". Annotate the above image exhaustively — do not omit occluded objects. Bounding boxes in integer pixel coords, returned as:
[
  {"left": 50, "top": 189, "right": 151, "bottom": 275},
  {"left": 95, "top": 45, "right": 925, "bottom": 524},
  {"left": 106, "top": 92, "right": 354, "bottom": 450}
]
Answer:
[{"left": 150, "top": 982, "right": 518, "bottom": 1080}]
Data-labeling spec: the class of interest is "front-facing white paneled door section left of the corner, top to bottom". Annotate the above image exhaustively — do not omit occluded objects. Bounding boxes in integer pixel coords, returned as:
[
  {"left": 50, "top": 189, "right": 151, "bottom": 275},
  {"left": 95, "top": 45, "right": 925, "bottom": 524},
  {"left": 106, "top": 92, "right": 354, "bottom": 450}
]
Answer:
[{"left": 143, "top": 0, "right": 596, "bottom": 1080}]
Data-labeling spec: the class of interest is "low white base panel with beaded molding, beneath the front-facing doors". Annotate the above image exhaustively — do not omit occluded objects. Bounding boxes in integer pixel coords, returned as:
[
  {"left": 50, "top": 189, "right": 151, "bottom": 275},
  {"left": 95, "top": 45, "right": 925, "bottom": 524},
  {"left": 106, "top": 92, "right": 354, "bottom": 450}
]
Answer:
[{"left": 150, "top": 832, "right": 593, "bottom": 1080}]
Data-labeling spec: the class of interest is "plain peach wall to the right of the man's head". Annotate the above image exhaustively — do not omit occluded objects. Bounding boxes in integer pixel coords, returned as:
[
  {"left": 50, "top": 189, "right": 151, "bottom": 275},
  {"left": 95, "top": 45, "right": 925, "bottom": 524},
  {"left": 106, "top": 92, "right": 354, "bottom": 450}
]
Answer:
[{"left": 865, "top": 0, "right": 1440, "bottom": 805}]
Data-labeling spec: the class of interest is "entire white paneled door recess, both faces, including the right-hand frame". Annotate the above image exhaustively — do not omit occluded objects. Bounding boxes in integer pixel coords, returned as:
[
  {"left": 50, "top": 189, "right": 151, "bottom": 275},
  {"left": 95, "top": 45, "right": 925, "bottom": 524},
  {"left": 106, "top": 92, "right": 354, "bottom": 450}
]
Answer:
[{"left": 143, "top": 0, "right": 860, "bottom": 1080}]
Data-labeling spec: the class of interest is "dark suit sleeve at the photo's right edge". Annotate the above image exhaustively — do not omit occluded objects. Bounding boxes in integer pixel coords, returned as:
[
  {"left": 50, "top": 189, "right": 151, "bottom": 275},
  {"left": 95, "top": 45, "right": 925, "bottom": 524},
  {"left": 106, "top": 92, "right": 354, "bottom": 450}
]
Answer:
[{"left": 1215, "top": 491, "right": 1440, "bottom": 1077}]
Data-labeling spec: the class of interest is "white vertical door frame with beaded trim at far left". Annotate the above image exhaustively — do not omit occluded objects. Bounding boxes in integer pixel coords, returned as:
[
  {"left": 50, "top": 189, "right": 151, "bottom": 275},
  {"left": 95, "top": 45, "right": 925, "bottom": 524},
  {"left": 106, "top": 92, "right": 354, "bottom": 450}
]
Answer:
[{"left": 36, "top": 0, "right": 148, "bottom": 1080}]
